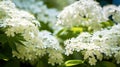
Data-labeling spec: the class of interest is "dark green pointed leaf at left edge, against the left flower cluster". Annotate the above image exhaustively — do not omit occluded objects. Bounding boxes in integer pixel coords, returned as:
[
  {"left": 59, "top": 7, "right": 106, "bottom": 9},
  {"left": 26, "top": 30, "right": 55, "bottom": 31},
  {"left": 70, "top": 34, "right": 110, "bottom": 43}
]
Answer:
[{"left": 0, "top": 28, "right": 26, "bottom": 52}]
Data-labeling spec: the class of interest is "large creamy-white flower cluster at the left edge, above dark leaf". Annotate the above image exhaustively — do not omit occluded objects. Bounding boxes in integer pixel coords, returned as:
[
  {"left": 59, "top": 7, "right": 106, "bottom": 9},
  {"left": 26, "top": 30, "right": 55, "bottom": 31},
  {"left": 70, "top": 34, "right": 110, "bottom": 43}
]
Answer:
[{"left": 0, "top": 0, "right": 45, "bottom": 60}]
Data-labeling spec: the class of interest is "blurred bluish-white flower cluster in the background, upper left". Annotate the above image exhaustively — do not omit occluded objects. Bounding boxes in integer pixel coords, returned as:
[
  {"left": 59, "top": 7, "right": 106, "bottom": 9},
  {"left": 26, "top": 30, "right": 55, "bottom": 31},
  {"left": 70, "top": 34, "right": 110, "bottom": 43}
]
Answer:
[{"left": 13, "top": 0, "right": 59, "bottom": 30}]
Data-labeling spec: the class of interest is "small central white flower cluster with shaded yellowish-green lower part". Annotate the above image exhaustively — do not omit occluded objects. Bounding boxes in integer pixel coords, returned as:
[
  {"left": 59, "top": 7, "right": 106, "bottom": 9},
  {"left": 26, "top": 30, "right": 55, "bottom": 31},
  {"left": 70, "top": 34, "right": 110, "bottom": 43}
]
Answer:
[{"left": 39, "top": 31, "right": 63, "bottom": 65}]
